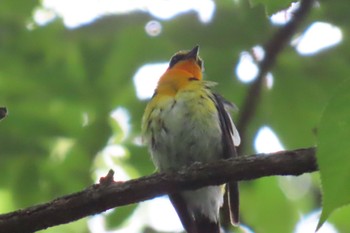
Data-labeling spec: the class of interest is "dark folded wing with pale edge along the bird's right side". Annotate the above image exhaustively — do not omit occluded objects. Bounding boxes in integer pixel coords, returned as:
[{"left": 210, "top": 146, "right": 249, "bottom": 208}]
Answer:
[{"left": 214, "top": 94, "right": 239, "bottom": 225}]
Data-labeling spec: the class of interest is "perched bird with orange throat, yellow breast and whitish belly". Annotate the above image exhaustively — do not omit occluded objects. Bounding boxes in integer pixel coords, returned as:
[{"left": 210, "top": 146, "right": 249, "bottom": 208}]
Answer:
[{"left": 142, "top": 46, "right": 240, "bottom": 233}]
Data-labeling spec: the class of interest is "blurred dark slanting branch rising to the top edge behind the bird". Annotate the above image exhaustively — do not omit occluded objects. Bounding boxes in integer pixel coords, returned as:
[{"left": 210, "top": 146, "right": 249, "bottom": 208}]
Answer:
[{"left": 237, "top": 0, "right": 314, "bottom": 154}]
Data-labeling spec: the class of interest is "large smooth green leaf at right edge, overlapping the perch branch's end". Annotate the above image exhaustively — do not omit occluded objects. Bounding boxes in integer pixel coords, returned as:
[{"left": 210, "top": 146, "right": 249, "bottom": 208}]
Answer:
[{"left": 317, "top": 78, "right": 350, "bottom": 228}]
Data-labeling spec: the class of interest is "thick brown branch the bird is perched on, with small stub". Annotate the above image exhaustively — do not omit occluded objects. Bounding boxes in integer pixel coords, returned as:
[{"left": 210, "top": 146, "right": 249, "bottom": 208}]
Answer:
[{"left": 0, "top": 148, "right": 318, "bottom": 233}]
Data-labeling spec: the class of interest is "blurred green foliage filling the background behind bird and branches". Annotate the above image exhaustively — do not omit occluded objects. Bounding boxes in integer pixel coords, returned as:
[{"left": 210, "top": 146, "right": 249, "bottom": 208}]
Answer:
[{"left": 0, "top": 0, "right": 350, "bottom": 233}]
